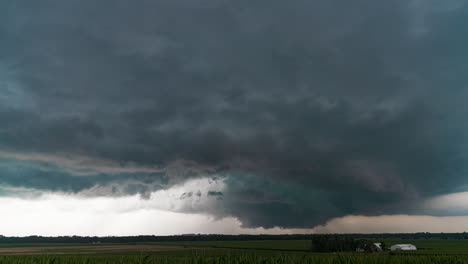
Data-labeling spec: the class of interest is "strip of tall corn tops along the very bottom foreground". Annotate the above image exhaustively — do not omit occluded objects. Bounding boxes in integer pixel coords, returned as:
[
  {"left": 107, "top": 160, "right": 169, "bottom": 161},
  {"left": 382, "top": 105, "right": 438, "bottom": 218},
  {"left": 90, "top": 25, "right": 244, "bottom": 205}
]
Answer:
[{"left": 0, "top": 255, "right": 468, "bottom": 264}]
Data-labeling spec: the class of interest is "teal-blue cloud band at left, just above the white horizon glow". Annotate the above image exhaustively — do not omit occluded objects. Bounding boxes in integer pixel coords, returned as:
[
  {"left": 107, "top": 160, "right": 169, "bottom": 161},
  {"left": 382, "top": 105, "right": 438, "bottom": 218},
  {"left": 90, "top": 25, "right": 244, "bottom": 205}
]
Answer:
[{"left": 0, "top": 159, "right": 169, "bottom": 197}]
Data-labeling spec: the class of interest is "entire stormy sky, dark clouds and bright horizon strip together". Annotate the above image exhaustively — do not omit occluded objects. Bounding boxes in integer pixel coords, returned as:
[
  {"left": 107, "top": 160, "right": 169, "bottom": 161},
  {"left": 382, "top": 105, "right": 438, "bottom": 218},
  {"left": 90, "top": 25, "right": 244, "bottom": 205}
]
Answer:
[{"left": 0, "top": 0, "right": 468, "bottom": 236}]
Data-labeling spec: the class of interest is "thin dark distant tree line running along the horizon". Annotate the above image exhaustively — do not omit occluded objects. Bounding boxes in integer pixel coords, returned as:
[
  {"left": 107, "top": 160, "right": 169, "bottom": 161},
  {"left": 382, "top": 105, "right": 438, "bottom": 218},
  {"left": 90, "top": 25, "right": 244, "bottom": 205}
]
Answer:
[{"left": 0, "top": 232, "right": 468, "bottom": 243}]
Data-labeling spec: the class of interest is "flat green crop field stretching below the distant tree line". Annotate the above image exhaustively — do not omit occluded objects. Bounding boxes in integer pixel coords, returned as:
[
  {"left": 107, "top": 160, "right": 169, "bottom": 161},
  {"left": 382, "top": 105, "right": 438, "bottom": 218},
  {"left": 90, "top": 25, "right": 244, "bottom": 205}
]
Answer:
[{"left": 0, "top": 239, "right": 468, "bottom": 264}]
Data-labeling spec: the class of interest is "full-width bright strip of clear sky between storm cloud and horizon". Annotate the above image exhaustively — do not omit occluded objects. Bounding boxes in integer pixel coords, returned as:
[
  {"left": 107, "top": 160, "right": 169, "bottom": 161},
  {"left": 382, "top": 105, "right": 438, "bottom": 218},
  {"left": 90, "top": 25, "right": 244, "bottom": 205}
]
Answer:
[{"left": 0, "top": 191, "right": 468, "bottom": 236}]
